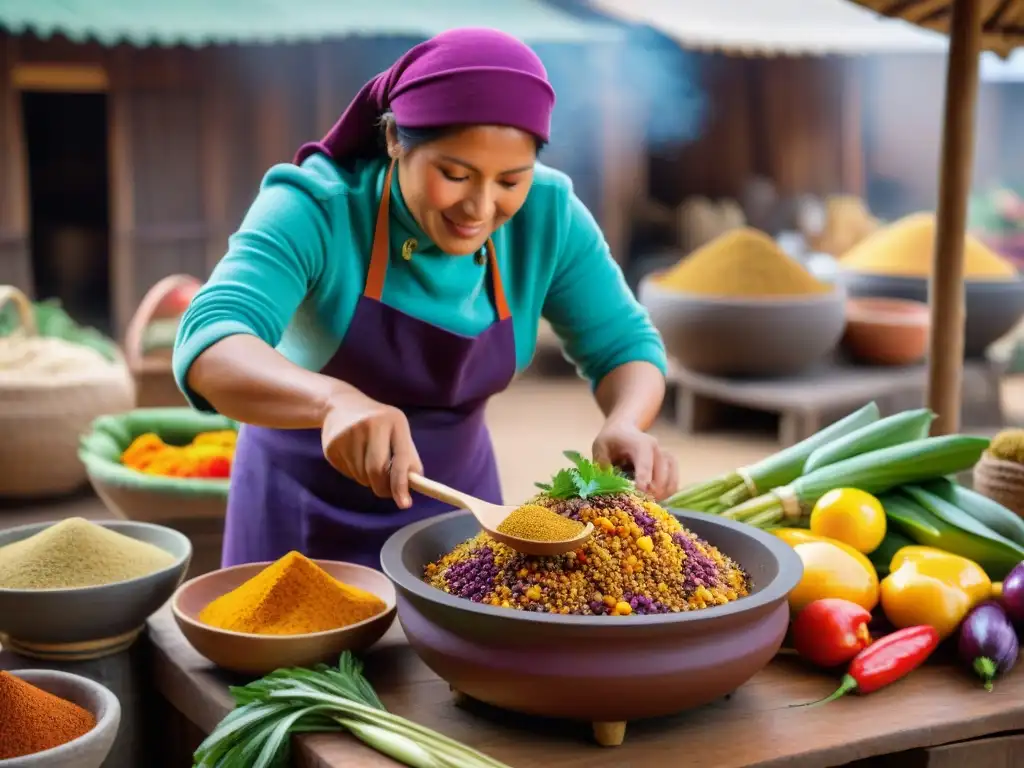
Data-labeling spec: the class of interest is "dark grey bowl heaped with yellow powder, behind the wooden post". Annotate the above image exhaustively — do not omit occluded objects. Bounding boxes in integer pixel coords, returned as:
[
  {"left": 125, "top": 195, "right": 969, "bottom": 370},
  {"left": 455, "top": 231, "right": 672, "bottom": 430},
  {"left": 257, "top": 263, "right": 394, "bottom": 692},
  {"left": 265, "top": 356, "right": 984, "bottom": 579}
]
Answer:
[{"left": 839, "top": 213, "right": 1024, "bottom": 357}]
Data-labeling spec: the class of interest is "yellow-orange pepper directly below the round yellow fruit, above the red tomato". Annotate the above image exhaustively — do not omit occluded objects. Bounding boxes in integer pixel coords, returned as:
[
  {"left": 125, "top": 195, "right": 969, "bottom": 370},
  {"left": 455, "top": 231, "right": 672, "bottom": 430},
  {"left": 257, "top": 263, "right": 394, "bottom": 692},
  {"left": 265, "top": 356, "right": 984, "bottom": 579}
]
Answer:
[{"left": 790, "top": 541, "right": 879, "bottom": 611}]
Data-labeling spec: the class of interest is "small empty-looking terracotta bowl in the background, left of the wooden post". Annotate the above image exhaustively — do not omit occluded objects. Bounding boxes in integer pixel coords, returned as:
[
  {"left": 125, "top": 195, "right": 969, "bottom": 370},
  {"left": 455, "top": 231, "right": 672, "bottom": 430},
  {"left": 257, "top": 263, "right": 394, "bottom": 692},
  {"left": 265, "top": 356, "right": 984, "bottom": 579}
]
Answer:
[{"left": 843, "top": 297, "right": 932, "bottom": 366}]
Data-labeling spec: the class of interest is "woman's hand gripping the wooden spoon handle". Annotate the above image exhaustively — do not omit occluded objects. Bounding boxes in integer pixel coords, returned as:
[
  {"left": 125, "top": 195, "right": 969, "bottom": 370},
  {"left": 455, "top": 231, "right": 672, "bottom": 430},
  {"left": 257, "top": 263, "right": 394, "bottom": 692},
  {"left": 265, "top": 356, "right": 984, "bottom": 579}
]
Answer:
[{"left": 321, "top": 390, "right": 423, "bottom": 509}]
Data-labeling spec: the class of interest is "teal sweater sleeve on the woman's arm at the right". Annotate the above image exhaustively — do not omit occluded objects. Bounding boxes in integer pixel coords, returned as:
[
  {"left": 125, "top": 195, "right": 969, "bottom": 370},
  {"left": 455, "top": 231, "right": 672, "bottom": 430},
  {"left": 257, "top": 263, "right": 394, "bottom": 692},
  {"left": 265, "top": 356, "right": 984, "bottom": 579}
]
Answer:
[{"left": 543, "top": 186, "right": 668, "bottom": 387}]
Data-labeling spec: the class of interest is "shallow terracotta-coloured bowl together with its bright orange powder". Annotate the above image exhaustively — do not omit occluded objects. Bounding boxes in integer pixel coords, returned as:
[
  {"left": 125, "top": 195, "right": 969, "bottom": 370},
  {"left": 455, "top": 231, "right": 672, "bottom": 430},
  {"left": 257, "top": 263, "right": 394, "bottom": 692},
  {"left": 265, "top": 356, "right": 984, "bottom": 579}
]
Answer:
[{"left": 171, "top": 552, "right": 395, "bottom": 675}]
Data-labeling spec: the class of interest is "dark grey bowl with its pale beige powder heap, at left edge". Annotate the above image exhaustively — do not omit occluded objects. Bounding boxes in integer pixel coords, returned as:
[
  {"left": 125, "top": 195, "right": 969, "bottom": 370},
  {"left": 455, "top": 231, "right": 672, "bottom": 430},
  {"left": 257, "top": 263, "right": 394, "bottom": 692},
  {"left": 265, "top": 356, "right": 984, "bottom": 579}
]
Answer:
[{"left": 0, "top": 517, "right": 191, "bottom": 660}]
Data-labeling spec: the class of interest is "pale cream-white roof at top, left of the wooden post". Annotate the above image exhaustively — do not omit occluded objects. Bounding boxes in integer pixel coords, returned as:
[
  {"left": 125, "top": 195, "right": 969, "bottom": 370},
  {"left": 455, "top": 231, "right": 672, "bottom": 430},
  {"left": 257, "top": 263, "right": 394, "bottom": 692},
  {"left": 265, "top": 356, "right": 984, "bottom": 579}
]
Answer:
[{"left": 589, "top": 0, "right": 948, "bottom": 55}]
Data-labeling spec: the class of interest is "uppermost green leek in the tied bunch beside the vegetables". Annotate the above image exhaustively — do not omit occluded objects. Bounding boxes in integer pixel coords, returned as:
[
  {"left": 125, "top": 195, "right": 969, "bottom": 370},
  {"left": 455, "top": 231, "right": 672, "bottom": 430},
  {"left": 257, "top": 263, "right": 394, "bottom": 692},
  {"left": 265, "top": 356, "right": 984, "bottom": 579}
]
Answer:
[{"left": 662, "top": 401, "right": 880, "bottom": 512}]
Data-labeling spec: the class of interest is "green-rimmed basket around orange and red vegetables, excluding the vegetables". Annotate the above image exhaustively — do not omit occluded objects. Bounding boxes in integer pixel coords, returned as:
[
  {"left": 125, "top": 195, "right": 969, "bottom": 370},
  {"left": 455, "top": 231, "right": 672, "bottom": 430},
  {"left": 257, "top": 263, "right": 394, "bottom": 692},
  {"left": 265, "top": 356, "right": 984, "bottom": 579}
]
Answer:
[{"left": 79, "top": 408, "right": 238, "bottom": 579}]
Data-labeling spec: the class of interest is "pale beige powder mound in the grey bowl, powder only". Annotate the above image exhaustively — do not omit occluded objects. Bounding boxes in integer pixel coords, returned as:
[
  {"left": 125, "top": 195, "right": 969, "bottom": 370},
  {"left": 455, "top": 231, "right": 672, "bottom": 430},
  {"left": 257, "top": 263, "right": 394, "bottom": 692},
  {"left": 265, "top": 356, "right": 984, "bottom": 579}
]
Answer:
[{"left": 0, "top": 517, "right": 175, "bottom": 590}]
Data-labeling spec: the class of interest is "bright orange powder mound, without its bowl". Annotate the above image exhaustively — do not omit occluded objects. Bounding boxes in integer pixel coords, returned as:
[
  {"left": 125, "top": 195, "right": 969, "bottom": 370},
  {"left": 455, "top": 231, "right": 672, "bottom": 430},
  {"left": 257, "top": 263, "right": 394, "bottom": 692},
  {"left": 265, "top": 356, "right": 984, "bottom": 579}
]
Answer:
[{"left": 199, "top": 552, "right": 387, "bottom": 635}]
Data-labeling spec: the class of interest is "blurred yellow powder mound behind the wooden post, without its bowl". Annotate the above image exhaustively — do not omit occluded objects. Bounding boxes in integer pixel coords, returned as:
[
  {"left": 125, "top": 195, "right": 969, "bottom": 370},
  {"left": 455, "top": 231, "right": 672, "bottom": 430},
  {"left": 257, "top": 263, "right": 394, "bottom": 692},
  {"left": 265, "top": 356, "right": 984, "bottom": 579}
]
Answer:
[{"left": 840, "top": 213, "right": 1017, "bottom": 280}]
